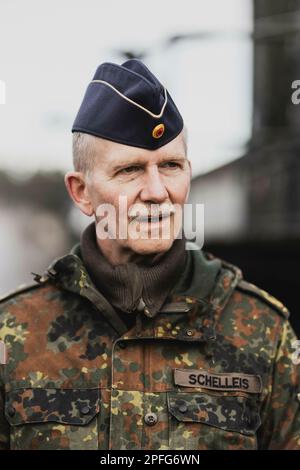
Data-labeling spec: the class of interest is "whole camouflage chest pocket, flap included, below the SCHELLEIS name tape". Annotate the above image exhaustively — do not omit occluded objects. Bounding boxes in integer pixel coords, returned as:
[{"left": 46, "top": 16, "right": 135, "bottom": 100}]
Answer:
[{"left": 168, "top": 391, "right": 261, "bottom": 450}]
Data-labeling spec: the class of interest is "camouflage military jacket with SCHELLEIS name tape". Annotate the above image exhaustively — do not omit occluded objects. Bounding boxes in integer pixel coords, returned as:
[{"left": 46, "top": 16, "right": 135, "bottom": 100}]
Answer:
[{"left": 0, "top": 244, "right": 300, "bottom": 450}]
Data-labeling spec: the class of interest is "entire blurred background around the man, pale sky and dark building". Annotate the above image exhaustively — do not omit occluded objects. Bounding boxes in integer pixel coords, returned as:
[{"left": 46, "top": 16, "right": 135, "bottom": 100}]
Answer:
[{"left": 0, "top": 0, "right": 300, "bottom": 335}]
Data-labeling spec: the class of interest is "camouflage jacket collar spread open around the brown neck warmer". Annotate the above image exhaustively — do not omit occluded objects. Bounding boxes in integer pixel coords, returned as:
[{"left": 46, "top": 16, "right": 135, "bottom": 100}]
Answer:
[{"left": 36, "top": 243, "right": 242, "bottom": 342}]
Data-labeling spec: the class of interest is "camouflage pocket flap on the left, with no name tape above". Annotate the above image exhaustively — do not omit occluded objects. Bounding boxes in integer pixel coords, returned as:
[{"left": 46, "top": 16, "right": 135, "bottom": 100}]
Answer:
[{"left": 5, "top": 388, "right": 100, "bottom": 426}]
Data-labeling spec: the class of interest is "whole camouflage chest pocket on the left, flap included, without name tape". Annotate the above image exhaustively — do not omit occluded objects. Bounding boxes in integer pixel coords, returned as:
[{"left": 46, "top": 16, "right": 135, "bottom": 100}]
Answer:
[{"left": 5, "top": 388, "right": 100, "bottom": 449}]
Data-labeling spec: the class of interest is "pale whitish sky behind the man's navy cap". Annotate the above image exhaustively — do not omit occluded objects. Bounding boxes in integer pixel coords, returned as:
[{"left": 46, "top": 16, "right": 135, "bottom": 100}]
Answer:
[{"left": 0, "top": 0, "right": 252, "bottom": 174}]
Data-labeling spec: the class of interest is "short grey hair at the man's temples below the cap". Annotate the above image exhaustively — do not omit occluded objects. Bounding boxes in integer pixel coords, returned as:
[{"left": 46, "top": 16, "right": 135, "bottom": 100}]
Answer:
[{"left": 72, "top": 126, "right": 188, "bottom": 174}]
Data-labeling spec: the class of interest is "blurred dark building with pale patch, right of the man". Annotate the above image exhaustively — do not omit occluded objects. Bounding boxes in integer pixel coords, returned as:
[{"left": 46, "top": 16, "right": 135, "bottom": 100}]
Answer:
[{"left": 190, "top": 0, "right": 300, "bottom": 334}]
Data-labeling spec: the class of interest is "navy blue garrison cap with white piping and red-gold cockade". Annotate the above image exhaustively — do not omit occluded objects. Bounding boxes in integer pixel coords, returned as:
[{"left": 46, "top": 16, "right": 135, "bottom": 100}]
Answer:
[{"left": 72, "top": 59, "right": 183, "bottom": 150}]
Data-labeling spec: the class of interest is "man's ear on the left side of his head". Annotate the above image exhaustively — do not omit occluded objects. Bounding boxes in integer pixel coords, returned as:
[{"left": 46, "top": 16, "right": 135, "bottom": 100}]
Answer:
[{"left": 65, "top": 171, "right": 94, "bottom": 217}]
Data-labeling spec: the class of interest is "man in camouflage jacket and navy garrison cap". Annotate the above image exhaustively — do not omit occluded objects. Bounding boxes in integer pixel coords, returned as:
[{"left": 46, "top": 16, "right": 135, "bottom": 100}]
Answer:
[{"left": 0, "top": 60, "right": 300, "bottom": 449}]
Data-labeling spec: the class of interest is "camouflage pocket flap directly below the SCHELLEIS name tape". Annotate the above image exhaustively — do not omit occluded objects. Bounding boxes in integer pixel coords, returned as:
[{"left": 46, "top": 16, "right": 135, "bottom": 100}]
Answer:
[{"left": 168, "top": 392, "right": 261, "bottom": 435}]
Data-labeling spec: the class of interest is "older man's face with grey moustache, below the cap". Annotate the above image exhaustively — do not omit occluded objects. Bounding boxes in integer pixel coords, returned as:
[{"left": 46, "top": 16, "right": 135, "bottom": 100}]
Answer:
[{"left": 87, "top": 133, "right": 191, "bottom": 254}]
